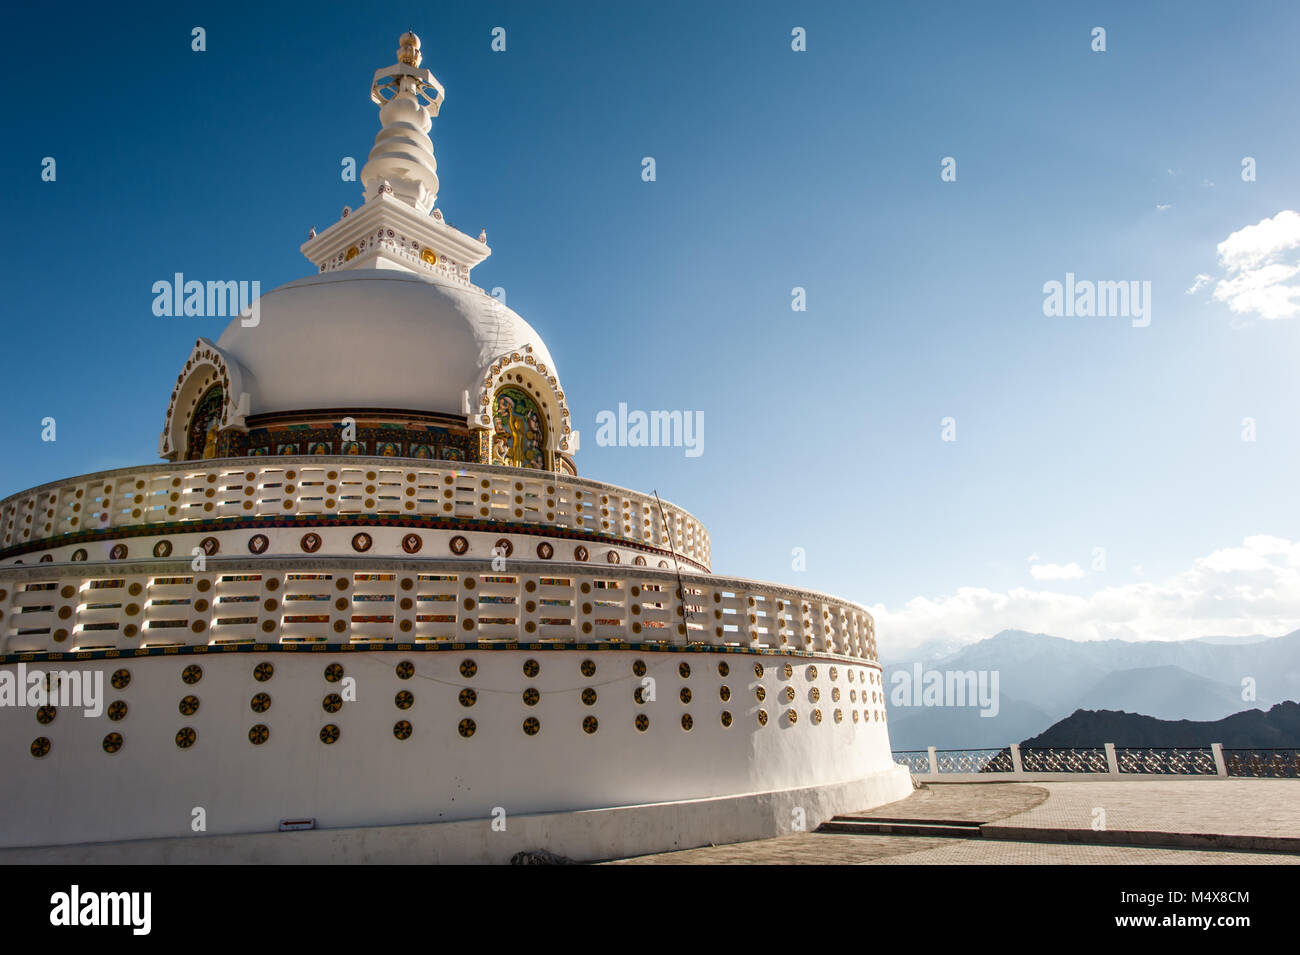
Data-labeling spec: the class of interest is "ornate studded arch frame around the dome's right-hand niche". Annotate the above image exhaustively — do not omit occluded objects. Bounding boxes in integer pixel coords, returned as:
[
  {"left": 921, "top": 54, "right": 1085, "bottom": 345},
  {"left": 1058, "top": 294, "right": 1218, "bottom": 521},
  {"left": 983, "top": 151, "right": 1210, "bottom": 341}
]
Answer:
[{"left": 469, "top": 346, "right": 576, "bottom": 470}]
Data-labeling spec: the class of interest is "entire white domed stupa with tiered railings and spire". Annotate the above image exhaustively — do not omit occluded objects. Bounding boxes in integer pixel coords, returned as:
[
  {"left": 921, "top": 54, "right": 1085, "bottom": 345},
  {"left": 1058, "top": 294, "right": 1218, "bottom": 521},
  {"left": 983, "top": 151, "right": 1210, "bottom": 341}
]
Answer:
[{"left": 0, "top": 32, "right": 911, "bottom": 861}]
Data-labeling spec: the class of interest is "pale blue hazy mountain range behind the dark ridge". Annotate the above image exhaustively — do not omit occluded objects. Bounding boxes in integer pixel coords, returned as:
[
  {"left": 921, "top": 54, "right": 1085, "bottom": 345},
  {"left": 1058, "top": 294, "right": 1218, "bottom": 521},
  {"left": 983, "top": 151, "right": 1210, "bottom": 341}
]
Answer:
[{"left": 885, "top": 630, "right": 1300, "bottom": 750}]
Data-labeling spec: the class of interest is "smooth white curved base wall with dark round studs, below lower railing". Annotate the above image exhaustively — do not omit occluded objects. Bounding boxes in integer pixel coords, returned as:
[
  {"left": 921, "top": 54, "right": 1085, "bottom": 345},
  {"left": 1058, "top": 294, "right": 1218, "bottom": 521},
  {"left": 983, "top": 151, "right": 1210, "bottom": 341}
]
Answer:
[{"left": 0, "top": 648, "right": 893, "bottom": 846}]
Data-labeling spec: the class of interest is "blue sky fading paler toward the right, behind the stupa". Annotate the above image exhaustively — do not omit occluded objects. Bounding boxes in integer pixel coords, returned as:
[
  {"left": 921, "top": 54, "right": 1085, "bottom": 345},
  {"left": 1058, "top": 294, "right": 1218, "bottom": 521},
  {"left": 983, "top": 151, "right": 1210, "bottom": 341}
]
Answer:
[{"left": 0, "top": 3, "right": 1300, "bottom": 642}]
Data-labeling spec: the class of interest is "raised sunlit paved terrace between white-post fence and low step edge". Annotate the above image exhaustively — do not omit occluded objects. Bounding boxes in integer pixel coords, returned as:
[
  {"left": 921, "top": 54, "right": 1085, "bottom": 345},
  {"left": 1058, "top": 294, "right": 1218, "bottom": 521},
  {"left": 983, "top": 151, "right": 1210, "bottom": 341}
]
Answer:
[{"left": 993, "top": 780, "right": 1300, "bottom": 837}]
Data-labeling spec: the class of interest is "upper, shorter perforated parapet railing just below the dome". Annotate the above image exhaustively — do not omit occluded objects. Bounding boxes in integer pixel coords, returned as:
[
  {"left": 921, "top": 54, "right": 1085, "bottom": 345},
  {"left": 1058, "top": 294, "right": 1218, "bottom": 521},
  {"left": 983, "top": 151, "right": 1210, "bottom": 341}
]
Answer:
[{"left": 0, "top": 455, "right": 710, "bottom": 569}]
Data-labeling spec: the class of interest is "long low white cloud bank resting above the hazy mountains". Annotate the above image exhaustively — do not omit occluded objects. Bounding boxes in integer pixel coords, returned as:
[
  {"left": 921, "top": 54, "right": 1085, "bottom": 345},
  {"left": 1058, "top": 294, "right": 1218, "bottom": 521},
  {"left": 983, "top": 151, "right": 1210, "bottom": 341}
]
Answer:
[{"left": 870, "top": 535, "right": 1300, "bottom": 656}]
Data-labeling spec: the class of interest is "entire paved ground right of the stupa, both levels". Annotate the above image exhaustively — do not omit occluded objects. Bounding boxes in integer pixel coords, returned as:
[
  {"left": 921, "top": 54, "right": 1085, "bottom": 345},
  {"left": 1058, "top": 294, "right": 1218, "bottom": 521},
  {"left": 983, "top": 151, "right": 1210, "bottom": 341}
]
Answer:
[{"left": 618, "top": 780, "right": 1300, "bottom": 865}]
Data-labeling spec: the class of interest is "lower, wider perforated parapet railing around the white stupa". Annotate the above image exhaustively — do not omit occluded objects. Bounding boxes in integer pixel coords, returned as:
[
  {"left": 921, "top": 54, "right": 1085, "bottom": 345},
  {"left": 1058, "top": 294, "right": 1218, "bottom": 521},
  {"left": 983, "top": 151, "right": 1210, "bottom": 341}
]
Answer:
[{"left": 0, "top": 557, "right": 884, "bottom": 660}]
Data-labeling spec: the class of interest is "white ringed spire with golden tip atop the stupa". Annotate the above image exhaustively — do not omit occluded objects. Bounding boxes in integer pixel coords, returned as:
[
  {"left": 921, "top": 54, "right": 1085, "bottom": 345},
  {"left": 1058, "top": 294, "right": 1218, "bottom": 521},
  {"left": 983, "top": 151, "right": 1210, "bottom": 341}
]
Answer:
[{"left": 361, "top": 30, "right": 443, "bottom": 214}]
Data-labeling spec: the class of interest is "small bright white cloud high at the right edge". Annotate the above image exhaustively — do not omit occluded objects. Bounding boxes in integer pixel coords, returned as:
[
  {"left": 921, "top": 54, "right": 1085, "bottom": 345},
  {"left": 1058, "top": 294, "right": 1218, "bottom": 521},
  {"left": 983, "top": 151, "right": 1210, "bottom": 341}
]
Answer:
[{"left": 1187, "top": 209, "right": 1300, "bottom": 320}]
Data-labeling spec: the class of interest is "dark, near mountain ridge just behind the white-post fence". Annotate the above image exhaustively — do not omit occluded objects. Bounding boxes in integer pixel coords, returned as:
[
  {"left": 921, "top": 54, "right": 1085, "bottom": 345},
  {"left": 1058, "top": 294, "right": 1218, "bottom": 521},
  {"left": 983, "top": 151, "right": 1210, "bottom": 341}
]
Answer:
[{"left": 1021, "top": 702, "right": 1300, "bottom": 750}]
